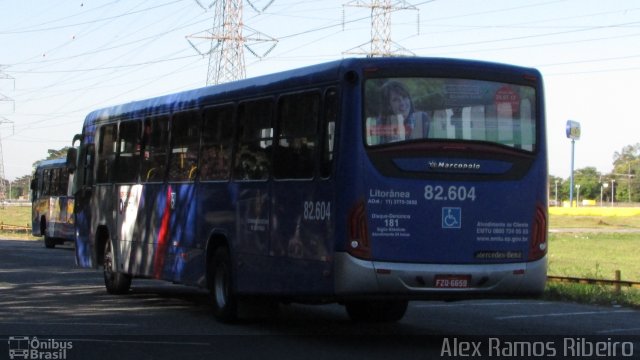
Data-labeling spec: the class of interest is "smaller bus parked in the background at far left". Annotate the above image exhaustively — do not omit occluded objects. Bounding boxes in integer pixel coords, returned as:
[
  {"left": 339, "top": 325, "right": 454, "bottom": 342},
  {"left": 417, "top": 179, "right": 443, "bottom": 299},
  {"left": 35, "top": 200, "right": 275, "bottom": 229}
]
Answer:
[{"left": 31, "top": 158, "right": 75, "bottom": 248}]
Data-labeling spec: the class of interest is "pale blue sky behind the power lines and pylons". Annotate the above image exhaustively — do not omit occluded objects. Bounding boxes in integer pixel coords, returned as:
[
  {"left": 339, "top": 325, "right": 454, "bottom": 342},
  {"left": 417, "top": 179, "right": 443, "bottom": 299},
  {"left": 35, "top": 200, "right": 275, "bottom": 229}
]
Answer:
[{"left": 0, "top": 0, "right": 640, "bottom": 180}]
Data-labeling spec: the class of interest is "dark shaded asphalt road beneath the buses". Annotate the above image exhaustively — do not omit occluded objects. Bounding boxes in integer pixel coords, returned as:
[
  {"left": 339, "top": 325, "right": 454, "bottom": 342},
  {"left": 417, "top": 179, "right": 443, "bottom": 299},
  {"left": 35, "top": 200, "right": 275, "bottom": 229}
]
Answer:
[{"left": 0, "top": 240, "right": 640, "bottom": 360}]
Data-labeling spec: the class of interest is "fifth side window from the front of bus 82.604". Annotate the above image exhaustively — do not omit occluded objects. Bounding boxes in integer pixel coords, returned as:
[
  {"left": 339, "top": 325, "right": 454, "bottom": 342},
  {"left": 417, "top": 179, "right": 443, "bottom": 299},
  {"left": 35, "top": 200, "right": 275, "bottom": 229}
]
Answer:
[{"left": 200, "top": 105, "right": 234, "bottom": 180}]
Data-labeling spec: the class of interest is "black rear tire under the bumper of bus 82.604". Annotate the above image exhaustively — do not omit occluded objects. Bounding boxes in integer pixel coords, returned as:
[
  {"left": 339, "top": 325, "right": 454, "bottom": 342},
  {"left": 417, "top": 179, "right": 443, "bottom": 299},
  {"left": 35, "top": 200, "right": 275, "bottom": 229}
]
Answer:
[{"left": 345, "top": 300, "right": 409, "bottom": 322}]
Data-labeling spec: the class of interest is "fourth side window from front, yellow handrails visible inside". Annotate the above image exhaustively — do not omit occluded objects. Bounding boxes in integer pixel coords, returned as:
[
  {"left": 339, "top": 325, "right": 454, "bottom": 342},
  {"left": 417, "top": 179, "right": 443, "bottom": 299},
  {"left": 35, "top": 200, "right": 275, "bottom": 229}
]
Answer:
[{"left": 169, "top": 111, "right": 200, "bottom": 181}]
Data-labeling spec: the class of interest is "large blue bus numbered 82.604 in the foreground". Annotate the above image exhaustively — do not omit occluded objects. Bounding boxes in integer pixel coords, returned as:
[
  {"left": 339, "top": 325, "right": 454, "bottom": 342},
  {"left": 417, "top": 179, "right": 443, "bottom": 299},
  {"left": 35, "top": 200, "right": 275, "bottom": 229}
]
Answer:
[{"left": 68, "top": 57, "right": 548, "bottom": 321}]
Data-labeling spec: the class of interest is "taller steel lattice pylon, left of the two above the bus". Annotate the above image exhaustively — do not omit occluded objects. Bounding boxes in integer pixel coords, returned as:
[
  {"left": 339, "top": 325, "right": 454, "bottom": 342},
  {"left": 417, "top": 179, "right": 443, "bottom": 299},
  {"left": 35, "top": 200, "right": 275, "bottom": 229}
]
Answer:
[{"left": 187, "top": 0, "right": 278, "bottom": 85}]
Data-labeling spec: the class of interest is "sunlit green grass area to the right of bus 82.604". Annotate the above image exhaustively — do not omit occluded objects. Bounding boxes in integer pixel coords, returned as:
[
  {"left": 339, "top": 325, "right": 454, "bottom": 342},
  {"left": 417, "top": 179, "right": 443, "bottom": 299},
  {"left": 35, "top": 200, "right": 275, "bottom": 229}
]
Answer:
[{"left": 545, "top": 208, "right": 640, "bottom": 307}]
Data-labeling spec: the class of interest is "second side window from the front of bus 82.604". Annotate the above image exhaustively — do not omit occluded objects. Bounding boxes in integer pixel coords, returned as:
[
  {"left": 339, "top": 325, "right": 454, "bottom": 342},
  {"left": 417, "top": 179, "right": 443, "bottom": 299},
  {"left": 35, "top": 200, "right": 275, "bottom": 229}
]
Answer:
[{"left": 115, "top": 121, "right": 140, "bottom": 183}]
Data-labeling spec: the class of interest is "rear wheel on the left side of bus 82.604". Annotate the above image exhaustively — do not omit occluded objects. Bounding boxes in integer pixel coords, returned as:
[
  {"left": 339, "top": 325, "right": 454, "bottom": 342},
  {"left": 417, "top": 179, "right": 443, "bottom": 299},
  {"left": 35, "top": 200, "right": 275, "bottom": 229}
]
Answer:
[{"left": 207, "top": 246, "right": 238, "bottom": 323}]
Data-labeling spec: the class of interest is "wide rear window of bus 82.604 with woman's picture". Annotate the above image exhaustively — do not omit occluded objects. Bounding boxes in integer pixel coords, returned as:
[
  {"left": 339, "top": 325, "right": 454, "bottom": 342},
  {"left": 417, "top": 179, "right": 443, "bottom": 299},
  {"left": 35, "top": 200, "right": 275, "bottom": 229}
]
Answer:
[{"left": 364, "top": 78, "right": 536, "bottom": 152}]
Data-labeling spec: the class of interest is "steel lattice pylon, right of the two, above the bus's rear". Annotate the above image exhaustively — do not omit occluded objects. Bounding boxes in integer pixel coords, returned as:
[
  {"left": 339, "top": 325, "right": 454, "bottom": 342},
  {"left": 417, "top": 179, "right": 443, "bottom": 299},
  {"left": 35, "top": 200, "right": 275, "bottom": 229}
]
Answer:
[{"left": 343, "top": 0, "right": 420, "bottom": 57}]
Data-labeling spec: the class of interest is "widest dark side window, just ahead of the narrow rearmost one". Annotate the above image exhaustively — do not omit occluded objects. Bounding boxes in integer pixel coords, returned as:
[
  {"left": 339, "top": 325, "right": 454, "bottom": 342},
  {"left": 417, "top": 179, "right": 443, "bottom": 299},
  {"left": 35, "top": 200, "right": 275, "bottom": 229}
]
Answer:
[{"left": 273, "top": 92, "right": 320, "bottom": 179}]
